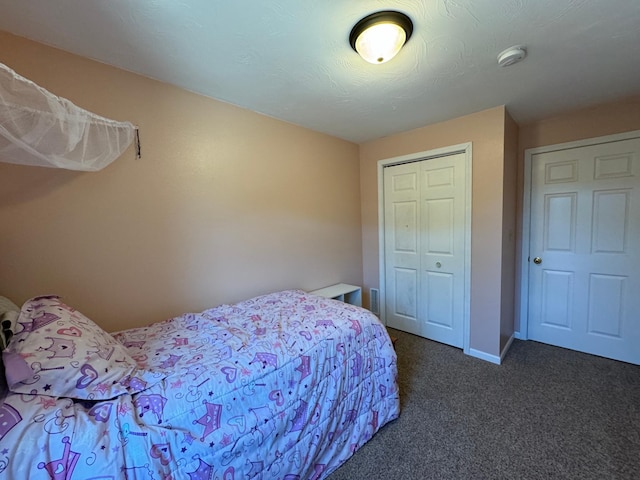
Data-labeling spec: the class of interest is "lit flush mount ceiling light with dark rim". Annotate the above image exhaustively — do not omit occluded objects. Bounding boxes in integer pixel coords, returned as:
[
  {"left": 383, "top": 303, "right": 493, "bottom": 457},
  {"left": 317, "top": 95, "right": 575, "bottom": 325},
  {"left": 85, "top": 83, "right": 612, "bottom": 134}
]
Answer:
[{"left": 349, "top": 10, "right": 413, "bottom": 64}]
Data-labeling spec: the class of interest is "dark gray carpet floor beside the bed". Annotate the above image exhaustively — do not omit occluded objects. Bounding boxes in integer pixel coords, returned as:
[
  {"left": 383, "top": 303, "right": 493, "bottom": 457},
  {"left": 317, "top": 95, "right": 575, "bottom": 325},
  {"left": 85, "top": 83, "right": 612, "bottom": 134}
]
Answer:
[{"left": 329, "top": 329, "right": 640, "bottom": 480}]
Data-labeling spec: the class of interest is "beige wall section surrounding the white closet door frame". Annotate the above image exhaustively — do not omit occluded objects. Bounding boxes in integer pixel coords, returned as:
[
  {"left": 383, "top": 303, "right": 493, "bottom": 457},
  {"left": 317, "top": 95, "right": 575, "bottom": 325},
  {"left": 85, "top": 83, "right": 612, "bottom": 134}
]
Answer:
[{"left": 360, "top": 107, "right": 506, "bottom": 355}]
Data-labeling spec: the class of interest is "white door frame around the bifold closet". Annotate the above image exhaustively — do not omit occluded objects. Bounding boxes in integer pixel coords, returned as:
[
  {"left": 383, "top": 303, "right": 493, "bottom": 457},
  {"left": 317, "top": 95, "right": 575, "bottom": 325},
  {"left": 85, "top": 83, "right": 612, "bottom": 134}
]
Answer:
[{"left": 378, "top": 142, "right": 473, "bottom": 354}]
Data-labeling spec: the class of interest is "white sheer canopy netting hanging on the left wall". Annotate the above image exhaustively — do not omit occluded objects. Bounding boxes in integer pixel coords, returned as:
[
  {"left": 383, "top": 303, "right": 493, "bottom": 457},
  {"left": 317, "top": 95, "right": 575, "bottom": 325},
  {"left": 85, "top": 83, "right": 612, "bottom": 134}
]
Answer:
[{"left": 0, "top": 63, "right": 136, "bottom": 171}]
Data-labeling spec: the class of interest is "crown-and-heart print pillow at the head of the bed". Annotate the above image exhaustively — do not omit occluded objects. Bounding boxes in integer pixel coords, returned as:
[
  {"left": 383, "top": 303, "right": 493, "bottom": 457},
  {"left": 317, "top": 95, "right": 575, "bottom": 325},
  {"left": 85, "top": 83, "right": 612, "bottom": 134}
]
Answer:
[{"left": 3, "top": 296, "right": 166, "bottom": 400}]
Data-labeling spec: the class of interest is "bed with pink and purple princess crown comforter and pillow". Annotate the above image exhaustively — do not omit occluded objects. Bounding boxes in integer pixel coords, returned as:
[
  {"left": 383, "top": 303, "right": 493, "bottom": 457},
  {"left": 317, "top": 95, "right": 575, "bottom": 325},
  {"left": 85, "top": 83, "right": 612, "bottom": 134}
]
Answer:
[{"left": 0, "top": 290, "right": 399, "bottom": 480}]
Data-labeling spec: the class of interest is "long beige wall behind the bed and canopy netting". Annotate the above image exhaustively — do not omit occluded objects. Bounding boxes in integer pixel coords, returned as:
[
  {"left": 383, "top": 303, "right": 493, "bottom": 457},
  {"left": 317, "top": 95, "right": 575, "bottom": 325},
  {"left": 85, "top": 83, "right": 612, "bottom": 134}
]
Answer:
[{"left": 0, "top": 32, "right": 362, "bottom": 331}]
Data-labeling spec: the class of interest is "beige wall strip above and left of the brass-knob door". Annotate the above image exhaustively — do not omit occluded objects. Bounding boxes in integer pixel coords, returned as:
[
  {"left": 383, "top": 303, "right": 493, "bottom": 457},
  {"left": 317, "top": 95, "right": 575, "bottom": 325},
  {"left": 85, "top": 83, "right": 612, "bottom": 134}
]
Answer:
[{"left": 515, "top": 95, "right": 640, "bottom": 331}]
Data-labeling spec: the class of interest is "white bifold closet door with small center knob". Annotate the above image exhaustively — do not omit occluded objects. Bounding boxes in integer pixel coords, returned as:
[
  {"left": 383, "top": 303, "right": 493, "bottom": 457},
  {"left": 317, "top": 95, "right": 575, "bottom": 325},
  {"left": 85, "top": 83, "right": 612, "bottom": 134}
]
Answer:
[{"left": 384, "top": 153, "right": 466, "bottom": 347}]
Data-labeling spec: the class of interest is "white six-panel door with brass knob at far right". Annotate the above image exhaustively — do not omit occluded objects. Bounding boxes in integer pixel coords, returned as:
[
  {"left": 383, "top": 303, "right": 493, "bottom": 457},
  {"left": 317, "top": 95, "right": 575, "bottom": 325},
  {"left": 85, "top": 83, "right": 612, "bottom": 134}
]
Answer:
[{"left": 528, "top": 139, "right": 640, "bottom": 364}]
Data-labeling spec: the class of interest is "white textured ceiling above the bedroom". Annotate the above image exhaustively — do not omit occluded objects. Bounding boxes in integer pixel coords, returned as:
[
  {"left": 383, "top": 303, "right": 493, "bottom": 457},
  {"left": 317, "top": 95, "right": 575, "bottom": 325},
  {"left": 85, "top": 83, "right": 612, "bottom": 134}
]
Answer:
[{"left": 0, "top": 0, "right": 640, "bottom": 142}]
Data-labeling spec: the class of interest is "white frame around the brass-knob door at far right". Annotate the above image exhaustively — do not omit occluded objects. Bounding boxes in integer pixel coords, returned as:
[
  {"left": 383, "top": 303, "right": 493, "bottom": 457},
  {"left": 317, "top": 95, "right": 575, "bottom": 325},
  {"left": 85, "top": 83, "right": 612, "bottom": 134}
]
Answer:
[{"left": 514, "top": 130, "right": 640, "bottom": 340}]
